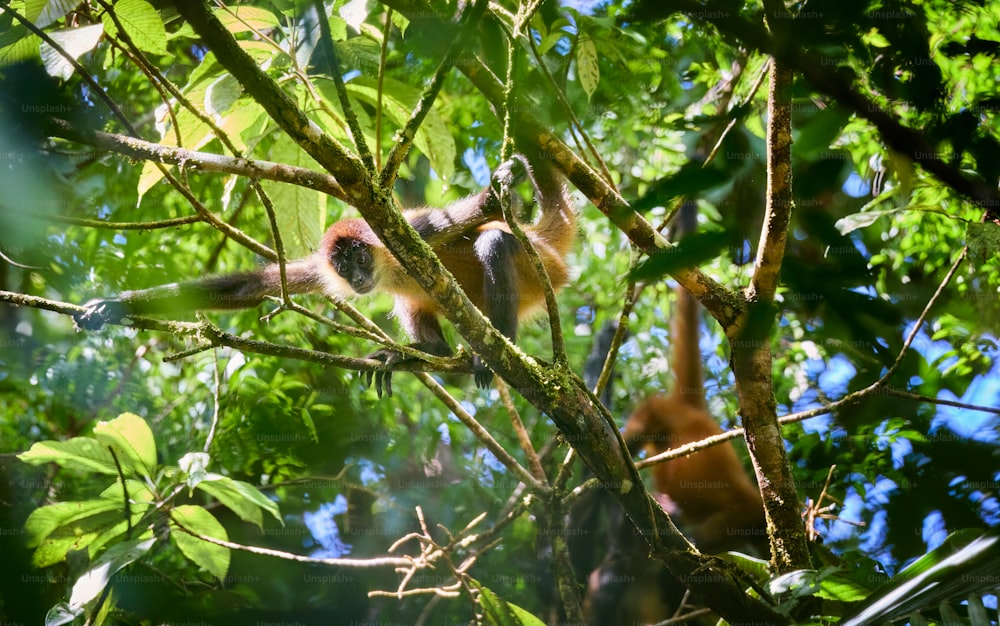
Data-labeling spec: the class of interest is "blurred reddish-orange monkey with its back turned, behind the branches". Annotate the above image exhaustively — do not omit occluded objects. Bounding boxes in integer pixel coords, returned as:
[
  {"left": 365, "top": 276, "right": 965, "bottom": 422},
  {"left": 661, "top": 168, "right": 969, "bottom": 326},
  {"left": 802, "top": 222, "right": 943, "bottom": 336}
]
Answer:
[{"left": 622, "top": 202, "right": 767, "bottom": 553}]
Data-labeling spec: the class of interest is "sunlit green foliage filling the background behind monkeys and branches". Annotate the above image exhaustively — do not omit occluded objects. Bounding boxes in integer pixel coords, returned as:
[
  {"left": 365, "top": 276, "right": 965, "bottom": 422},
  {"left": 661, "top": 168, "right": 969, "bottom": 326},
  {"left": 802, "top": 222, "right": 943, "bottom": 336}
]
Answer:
[{"left": 0, "top": 0, "right": 1000, "bottom": 624}]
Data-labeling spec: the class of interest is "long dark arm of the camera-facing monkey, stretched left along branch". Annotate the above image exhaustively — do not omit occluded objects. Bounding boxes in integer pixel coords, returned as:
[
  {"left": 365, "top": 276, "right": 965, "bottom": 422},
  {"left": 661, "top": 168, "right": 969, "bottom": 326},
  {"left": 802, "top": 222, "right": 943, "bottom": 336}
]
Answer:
[{"left": 74, "top": 258, "right": 323, "bottom": 330}]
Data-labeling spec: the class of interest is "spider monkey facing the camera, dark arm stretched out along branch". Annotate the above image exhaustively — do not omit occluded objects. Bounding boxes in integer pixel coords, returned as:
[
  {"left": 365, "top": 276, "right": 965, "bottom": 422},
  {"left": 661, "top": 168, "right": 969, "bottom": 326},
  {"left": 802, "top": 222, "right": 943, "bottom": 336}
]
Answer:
[{"left": 74, "top": 156, "right": 576, "bottom": 397}]
